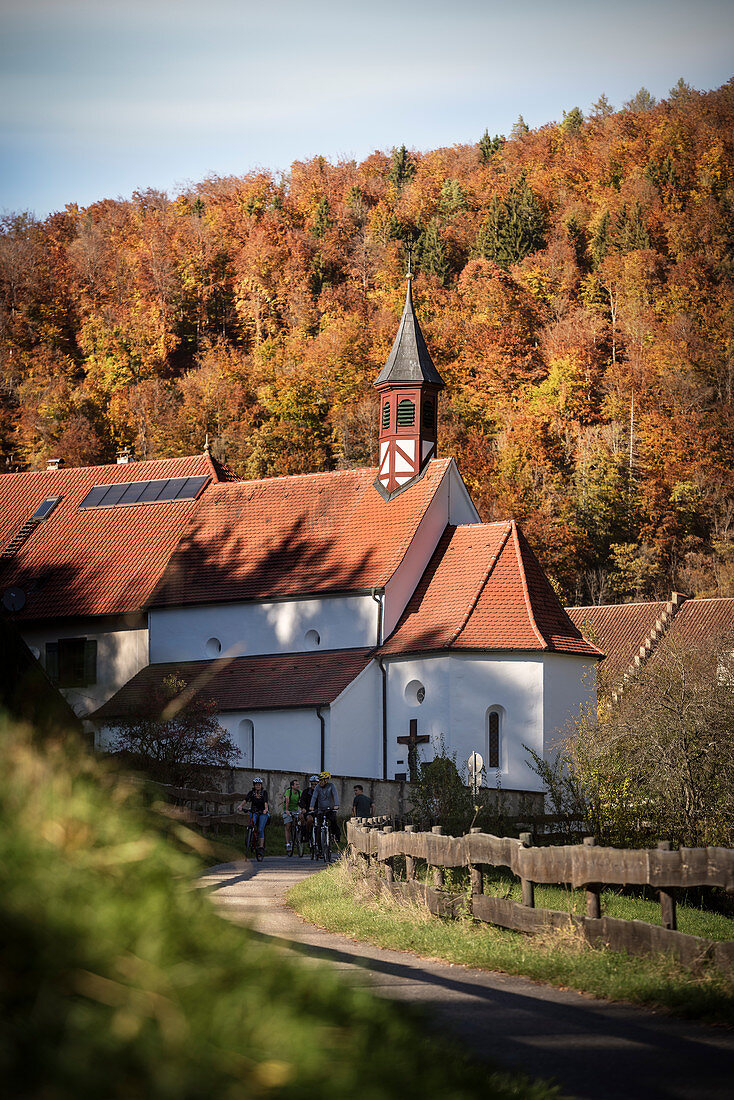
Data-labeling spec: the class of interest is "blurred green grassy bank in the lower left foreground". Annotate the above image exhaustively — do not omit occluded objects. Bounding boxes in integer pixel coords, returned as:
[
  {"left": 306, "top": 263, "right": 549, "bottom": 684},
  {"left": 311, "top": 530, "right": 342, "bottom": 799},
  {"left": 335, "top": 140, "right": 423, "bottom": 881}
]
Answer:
[{"left": 0, "top": 725, "right": 556, "bottom": 1100}]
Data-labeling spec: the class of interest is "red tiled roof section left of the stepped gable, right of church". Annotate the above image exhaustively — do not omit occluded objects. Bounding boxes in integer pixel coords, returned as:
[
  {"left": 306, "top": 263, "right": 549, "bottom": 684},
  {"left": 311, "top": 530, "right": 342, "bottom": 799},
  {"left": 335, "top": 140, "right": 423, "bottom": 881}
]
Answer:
[{"left": 566, "top": 601, "right": 669, "bottom": 689}]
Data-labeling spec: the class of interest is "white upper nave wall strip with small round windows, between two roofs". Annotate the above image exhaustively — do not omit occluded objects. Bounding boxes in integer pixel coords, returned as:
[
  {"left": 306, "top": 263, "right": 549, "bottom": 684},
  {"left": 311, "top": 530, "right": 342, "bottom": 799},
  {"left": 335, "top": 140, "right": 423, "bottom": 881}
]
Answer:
[{"left": 150, "top": 594, "right": 379, "bottom": 664}]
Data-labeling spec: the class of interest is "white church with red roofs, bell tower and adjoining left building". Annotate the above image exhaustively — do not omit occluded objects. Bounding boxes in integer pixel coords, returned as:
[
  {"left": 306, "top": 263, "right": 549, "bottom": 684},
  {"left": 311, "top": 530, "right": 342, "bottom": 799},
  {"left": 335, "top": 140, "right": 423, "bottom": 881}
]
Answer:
[{"left": 0, "top": 278, "right": 602, "bottom": 791}]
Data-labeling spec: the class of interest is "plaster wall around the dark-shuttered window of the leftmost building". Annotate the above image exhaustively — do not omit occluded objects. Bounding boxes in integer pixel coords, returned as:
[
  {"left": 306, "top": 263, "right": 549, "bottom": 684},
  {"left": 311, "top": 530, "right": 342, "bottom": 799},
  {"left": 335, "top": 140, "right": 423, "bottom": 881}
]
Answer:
[{"left": 21, "top": 616, "right": 149, "bottom": 717}]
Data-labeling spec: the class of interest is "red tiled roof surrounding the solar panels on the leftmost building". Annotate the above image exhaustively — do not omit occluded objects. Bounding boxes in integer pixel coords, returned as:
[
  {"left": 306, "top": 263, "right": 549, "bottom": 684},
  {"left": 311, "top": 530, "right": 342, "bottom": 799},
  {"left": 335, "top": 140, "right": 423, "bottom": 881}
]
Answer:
[{"left": 0, "top": 454, "right": 226, "bottom": 619}]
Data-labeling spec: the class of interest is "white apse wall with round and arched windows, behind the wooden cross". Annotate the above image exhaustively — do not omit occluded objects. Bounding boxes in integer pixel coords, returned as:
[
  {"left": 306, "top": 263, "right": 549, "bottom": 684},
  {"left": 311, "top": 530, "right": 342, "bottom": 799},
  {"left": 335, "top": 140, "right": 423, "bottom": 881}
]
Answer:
[{"left": 387, "top": 653, "right": 544, "bottom": 791}]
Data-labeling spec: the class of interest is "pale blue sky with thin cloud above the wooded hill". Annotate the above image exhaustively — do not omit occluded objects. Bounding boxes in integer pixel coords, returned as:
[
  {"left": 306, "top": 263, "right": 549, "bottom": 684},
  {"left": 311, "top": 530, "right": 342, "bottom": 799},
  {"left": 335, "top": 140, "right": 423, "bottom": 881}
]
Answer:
[{"left": 0, "top": 0, "right": 734, "bottom": 218}]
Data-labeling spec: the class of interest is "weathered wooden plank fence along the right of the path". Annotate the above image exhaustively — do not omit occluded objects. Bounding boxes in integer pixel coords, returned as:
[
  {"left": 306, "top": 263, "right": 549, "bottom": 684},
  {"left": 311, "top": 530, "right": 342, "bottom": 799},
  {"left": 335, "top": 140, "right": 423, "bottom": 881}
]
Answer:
[{"left": 347, "top": 822, "right": 734, "bottom": 974}]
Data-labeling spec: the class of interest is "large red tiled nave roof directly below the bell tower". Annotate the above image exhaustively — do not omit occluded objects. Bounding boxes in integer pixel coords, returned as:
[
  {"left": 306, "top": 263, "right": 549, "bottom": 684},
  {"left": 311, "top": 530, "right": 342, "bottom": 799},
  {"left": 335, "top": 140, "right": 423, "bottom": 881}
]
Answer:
[{"left": 150, "top": 459, "right": 450, "bottom": 607}]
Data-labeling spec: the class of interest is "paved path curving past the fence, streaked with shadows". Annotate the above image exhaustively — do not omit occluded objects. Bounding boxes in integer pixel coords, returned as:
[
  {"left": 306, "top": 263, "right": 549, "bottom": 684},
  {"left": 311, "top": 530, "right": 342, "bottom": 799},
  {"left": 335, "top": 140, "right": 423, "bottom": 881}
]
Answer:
[{"left": 202, "top": 857, "right": 734, "bottom": 1100}]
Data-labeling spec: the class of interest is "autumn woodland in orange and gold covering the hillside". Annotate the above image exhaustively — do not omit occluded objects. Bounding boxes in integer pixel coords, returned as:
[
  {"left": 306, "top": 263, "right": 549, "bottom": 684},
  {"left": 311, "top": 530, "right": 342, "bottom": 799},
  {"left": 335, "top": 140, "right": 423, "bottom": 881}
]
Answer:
[{"left": 0, "top": 81, "right": 734, "bottom": 603}]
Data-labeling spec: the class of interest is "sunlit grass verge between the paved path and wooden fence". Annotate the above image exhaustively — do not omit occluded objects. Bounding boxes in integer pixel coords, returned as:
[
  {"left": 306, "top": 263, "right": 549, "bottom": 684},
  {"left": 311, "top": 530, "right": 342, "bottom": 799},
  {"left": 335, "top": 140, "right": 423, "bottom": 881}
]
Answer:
[{"left": 288, "top": 860, "right": 734, "bottom": 1025}]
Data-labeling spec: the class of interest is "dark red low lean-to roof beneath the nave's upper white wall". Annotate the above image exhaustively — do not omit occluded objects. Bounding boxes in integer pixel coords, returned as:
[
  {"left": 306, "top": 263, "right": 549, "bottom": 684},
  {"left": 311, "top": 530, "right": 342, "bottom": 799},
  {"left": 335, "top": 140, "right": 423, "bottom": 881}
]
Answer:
[{"left": 90, "top": 649, "right": 373, "bottom": 722}]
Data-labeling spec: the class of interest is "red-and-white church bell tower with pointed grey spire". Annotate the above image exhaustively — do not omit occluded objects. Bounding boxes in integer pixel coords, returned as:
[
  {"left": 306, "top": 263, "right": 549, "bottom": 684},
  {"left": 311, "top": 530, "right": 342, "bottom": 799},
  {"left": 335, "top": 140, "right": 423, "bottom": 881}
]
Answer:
[{"left": 374, "top": 275, "right": 445, "bottom": 499}]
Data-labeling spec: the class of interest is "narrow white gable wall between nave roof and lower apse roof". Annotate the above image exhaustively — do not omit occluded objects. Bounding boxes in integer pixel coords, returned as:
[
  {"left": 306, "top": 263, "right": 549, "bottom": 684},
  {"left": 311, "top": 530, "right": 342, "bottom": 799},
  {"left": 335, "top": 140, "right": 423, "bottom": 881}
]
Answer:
[{"left": 382, "top": 461, "right": 480, "bottom": 641}]
